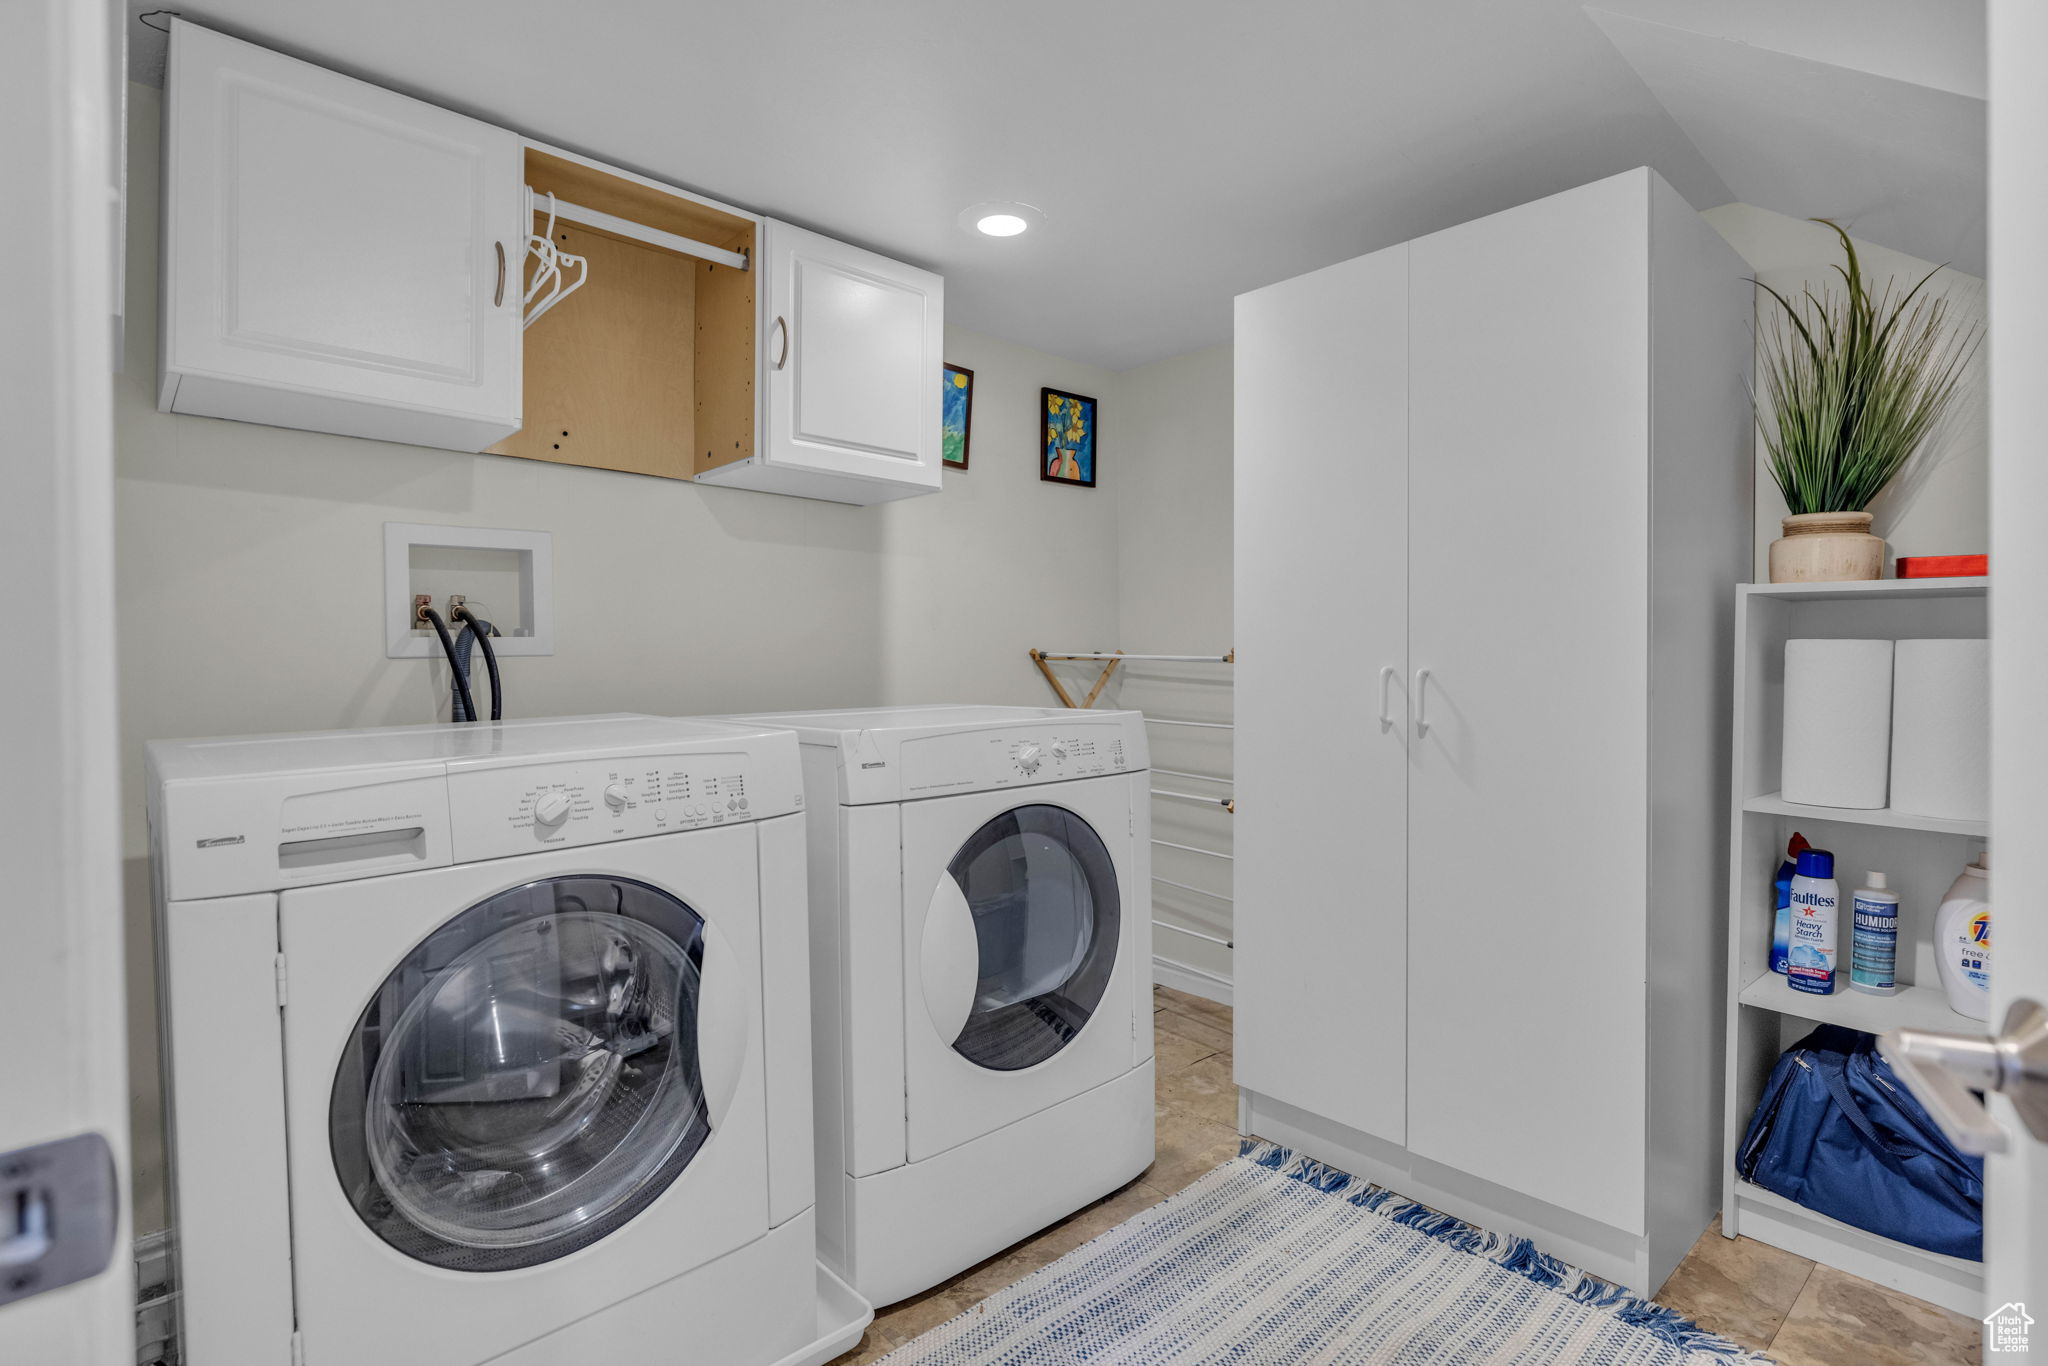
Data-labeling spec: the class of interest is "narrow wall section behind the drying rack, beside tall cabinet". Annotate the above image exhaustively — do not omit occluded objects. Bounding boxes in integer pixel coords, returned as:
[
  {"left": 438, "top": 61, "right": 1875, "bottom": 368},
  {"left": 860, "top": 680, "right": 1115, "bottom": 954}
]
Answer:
[{"left": 1114, "top": 346, "right": 1233, "bottom": 997}]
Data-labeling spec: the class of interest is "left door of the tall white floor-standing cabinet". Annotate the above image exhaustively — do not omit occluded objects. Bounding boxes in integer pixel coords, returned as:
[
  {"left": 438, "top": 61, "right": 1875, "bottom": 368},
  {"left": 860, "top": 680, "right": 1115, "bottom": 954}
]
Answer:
[{"left": 1233, "top": 246, "right": 1427, "bottom": 1143}]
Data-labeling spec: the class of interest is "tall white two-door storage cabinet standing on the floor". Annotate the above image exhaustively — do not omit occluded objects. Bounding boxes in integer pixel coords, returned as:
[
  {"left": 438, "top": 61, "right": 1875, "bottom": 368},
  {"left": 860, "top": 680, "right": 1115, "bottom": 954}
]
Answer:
[{"left": 1235, "top": 170, "right": 1751, "bottom": 1290}]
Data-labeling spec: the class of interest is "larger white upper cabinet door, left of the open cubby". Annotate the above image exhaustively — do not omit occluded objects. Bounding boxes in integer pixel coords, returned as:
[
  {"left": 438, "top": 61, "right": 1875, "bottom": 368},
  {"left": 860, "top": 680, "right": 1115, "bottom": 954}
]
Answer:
[{"left": 160, "top": 20, "right": 526, "bottom": 451}]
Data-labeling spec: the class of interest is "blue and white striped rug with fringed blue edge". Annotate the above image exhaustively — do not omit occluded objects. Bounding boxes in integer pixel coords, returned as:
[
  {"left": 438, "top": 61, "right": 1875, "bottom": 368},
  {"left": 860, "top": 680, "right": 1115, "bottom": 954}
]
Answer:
[{"left": 879, "top": 1143, "right": 1767, "bottom": 1366}]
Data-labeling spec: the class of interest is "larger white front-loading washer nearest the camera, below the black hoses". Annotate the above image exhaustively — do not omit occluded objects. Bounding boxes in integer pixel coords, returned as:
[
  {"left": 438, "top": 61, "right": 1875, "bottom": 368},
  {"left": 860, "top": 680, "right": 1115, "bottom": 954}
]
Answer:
[{"left": 150, "top": 717, "right": 872, "bottom": 1366}]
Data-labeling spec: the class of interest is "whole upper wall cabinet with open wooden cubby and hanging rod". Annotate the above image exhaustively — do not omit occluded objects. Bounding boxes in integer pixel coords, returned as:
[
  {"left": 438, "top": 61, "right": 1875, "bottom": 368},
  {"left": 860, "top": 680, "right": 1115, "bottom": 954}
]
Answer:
[{"left": 160, "top": 20, "right": 944, "bottom": 504}]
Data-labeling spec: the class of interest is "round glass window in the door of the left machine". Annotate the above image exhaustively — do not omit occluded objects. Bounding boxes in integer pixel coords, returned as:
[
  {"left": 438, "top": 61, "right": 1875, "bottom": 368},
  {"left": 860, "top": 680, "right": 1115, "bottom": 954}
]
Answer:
[{"left": 328, "top": 877, "right": 711, "bottom": 1272}]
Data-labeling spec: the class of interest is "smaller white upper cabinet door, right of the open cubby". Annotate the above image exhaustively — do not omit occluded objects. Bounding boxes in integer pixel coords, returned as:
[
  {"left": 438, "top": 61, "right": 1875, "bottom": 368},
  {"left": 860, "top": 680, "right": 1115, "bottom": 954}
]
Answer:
[{"left": 753, "top": 221, "right": 946, "bottom": 502}]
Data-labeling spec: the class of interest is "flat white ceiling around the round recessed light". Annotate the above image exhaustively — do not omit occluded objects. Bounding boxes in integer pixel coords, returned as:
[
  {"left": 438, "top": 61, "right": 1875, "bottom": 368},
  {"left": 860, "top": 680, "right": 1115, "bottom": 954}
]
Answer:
[{"left": 135, "top": 0, "right": 1982, "bottom": 369}]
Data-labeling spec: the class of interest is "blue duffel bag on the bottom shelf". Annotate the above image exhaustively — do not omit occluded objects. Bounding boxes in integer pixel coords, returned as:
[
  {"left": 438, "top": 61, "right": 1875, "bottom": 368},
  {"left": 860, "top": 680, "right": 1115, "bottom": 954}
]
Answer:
[{"left": 1735, "top": 1024, "right": 1985, "bottom": 1262}]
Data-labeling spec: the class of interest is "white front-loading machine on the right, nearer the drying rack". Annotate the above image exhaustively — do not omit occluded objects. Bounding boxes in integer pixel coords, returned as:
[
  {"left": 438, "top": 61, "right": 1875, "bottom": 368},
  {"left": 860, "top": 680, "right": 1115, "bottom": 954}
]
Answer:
[{"left": 720, "top": 707, "right": 1153, "bottom": 1305}]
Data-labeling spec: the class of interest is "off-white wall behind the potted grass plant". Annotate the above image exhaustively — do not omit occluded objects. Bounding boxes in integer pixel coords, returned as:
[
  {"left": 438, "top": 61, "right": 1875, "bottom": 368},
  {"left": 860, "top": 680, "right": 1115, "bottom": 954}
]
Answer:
[{"left": 1704, "top": 205, "right": 1991, "bottom": 582}]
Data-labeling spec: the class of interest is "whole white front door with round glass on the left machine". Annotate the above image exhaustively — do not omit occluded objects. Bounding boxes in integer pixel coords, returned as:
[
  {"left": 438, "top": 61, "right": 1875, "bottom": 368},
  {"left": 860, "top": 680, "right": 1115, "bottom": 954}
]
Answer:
[{"left": 281, "top": 827, "right": 768, "bottom": 1360}]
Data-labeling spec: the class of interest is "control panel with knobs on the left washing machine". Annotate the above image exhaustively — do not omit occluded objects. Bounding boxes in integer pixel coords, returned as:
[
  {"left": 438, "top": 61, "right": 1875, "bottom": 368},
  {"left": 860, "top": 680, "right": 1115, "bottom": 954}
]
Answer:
[{"left": 449, "top": 754, "right": 758, "bottom": 862}]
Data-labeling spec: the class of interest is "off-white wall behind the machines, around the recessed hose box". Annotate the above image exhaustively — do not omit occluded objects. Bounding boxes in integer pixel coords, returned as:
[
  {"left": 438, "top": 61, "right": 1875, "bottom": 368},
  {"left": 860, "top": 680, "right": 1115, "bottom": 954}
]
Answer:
[{"left": 115, "top": 86, "right": 1120, "bottom": 1231}]
